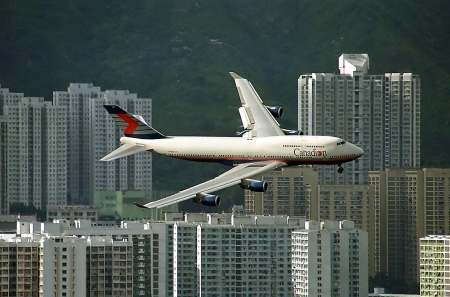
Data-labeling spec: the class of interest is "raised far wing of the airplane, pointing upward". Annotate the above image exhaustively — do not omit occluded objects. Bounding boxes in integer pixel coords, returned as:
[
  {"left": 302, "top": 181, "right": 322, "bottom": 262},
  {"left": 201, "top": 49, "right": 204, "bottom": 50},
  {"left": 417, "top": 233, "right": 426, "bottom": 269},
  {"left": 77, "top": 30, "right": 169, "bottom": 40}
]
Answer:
[{"left": 230, "top": 72, "right": 285, "bottom": 138}]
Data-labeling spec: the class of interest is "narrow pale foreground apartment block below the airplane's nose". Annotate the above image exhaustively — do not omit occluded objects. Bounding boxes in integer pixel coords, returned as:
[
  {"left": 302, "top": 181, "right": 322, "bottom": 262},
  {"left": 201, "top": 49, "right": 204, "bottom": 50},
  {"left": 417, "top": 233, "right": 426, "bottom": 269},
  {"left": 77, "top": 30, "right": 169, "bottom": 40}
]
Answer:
[{"left": 292, "top": 221, "right": 369, "bottom": 297}]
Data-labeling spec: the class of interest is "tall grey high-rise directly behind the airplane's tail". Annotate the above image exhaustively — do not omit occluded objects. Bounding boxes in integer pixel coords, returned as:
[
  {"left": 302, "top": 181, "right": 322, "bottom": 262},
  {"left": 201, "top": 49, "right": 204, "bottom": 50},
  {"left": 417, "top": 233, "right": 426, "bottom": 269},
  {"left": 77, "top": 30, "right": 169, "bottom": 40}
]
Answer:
[{"left": 53, "top": 83, "right": 152, "bottom": 204}]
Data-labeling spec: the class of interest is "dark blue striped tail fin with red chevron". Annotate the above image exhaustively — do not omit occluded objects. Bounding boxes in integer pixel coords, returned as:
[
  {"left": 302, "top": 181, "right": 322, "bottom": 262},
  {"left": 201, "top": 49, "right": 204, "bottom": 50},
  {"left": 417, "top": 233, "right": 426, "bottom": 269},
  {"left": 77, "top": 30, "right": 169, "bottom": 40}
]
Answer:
[{"left": 103, "top": 105, "right": 166, "bottom": 139}]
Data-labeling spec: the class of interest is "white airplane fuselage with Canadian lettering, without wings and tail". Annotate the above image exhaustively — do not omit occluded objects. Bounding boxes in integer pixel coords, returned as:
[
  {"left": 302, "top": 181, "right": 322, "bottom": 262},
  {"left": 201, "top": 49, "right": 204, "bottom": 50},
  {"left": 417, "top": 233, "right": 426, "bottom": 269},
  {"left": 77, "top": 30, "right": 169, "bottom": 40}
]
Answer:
[{"left": 120, "top": 135, "right": 364, "bottom": 165}]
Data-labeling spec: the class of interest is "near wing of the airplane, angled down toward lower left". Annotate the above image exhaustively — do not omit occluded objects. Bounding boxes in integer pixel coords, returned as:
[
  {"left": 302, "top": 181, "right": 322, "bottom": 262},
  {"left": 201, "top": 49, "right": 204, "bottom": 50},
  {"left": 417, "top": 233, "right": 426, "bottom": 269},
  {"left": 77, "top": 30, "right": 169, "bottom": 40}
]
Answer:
[{"left": 134, "top": 162, "right": 287, "bottom": 208}]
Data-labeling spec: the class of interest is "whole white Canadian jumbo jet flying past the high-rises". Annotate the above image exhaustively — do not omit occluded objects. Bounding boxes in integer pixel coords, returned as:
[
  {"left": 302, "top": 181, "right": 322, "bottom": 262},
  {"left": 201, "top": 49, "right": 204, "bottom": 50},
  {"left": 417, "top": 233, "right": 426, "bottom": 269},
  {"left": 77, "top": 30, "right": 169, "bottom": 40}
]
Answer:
[{"left": 100, "top": 72, "right": 364, "bottom": 208}]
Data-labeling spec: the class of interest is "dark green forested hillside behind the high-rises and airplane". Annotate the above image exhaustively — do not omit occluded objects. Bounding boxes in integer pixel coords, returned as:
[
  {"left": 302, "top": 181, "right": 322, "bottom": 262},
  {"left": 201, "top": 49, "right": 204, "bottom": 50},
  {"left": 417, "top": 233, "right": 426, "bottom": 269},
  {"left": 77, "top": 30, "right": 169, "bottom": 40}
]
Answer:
[{"left": 0, "top": 0, "right": 450, "bottom": 209}]
